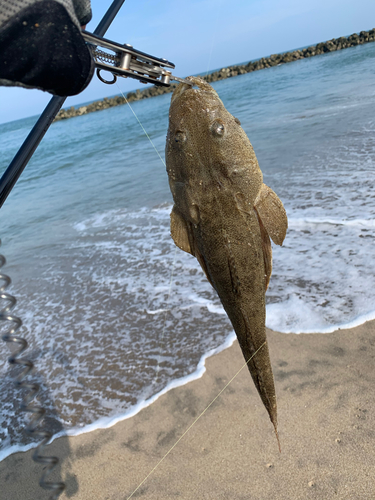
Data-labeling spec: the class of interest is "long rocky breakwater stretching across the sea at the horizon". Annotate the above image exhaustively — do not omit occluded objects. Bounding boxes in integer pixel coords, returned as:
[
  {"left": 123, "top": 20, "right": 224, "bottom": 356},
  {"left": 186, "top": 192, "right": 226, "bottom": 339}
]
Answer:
[{"left": 54, "top": 28, "right": 375, "bottom": 121}]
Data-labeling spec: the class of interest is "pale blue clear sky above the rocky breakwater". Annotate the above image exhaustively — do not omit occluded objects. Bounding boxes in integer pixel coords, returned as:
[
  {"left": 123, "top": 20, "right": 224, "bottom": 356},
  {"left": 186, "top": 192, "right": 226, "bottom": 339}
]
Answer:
[{"left": 0, "top": 0, "right": 375, "bottom": 123}]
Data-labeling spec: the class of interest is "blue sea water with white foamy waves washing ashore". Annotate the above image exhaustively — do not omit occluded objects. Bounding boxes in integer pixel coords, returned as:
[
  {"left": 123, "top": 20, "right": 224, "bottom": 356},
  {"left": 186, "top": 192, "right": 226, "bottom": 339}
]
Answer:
[{"left": 0, "top": 43, "right": 375, "bottom": 459}]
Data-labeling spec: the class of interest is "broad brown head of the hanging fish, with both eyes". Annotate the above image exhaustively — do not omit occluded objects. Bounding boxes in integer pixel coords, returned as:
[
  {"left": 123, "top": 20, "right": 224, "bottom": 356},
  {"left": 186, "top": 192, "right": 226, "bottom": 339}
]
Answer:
[{"left": 166, "top": 77, "right": 263, "bottom": 214}]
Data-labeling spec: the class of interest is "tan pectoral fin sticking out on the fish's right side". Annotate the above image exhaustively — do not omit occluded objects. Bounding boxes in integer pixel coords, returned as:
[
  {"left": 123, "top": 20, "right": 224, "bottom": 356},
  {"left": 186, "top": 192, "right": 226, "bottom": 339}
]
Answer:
[{"left": 254, "top": 184, "right": 288, "bottom": 245}]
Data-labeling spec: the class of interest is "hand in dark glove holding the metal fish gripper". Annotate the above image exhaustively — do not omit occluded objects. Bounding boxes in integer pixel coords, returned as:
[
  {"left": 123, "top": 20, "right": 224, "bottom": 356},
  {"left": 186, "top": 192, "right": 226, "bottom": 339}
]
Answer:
[{"left": 0, "top": 0, "right": 95, "bottom": 96}]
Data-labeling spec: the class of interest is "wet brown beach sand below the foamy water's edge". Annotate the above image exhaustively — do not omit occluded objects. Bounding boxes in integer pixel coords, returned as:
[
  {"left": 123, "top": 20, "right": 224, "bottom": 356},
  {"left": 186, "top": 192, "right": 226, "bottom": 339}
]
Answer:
[{"left": 0, "top": 321, "right": 375, "bottom": 500}]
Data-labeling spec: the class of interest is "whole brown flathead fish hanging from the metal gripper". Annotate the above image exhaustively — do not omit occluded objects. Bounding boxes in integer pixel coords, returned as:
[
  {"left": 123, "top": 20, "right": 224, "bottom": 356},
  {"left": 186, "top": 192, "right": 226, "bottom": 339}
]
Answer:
[{"left": 165, "top": 77, "right": 288, "bottom": 449}]
